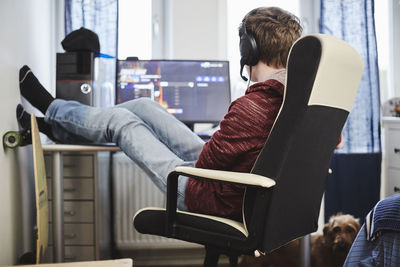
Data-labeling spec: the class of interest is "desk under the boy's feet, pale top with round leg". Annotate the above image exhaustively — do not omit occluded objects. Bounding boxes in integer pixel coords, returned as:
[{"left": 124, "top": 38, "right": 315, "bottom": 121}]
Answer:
[{"left": 43, "top": 144, "right": 120, "bottom": 262}]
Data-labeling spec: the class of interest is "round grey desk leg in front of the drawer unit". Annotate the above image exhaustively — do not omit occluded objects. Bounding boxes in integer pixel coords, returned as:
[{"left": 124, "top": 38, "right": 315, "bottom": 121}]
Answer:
[{"left": 53, "top": 151, "right": 64, "bottom": 262}]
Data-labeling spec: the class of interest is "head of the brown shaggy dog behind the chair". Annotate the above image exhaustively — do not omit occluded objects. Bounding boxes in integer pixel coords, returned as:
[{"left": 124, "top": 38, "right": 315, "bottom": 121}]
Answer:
[{"left": 324, "top": 213, "right": 361, "bottom": 254}]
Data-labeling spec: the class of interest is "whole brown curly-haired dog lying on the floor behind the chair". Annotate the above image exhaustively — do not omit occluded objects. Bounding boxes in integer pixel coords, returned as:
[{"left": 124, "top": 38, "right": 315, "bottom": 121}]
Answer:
[{"left": 240, "top": 213, "right": 361, "bottom": 267}]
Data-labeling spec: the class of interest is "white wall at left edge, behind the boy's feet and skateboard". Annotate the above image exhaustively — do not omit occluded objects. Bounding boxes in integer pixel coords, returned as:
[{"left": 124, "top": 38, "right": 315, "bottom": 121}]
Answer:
[{"left": 0, "top": 0, "right": 59, "bottom": 266}]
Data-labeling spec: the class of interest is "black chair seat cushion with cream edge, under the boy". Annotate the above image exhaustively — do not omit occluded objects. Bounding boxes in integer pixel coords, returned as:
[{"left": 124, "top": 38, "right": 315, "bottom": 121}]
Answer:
[{"left": 133, "top": 208, "right": 248, "bottom": 239}]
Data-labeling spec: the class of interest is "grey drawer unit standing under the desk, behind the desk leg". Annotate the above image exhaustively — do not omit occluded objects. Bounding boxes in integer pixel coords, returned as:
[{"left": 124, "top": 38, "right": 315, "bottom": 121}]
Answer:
[{"left": 45, "top": 152, "right": 109, "bottom": 262}]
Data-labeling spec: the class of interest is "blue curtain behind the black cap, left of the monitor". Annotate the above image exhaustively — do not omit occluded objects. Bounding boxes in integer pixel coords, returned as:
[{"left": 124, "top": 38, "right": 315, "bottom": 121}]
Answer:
[{"left": 65, "top": 0, "right": 118, "bottom": 57}]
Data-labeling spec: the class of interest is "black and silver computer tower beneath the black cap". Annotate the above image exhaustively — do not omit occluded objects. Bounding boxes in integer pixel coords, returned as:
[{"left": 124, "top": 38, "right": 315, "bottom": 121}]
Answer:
[{"left": 56, "top": 52, "right": 115, "bottom": 107}]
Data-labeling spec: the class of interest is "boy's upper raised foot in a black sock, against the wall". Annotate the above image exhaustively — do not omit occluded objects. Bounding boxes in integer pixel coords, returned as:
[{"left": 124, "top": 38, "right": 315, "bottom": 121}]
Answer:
[{"left": 19, "top": 65, "right": 54, "bottom": 114}]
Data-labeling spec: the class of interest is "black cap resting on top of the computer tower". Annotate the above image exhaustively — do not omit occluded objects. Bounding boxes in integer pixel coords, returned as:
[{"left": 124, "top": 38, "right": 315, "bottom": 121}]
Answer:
[{"left": 61, "top": 27, "right": 100, "bottom": 53}]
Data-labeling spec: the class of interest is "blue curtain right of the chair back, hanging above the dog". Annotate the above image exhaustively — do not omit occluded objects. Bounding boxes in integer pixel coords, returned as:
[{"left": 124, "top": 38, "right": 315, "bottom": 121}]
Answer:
[{"left": 320, "top": 0, "right": 381, "bottom": 222}]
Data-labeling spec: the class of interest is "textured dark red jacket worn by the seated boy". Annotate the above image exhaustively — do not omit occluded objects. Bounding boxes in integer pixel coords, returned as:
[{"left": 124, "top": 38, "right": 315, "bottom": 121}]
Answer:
[{"left": 185, "top": 79, "right": 284, "bottom": 216}]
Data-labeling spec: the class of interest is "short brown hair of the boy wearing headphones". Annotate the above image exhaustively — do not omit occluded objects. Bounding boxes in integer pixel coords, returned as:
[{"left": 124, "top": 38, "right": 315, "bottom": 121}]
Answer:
[{"left": 239, "top": 7, "right": 303, "bottom": 68}]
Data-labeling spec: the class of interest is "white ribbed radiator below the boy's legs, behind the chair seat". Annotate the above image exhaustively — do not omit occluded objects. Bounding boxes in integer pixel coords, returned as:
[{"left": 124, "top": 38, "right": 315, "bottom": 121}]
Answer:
[{"left": 113, "top": 152, "right": 197, "bottom": 250}]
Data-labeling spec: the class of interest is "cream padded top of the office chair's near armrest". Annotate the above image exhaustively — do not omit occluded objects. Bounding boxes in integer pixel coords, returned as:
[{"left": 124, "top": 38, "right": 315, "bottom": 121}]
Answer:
[{"left": 175, "top": 167, "right": 276, "bottom": 188}]
